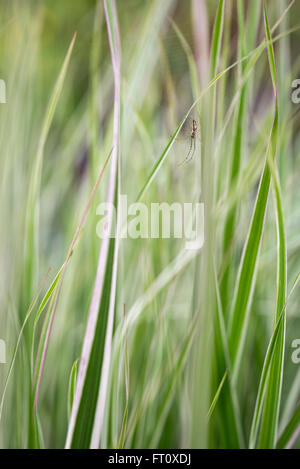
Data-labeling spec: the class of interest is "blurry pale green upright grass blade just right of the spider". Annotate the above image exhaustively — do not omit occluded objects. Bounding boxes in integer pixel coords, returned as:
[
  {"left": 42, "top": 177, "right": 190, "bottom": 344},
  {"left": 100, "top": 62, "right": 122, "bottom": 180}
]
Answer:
[{"left": 189, "top": 0, "right": 225, "bottom": 448}]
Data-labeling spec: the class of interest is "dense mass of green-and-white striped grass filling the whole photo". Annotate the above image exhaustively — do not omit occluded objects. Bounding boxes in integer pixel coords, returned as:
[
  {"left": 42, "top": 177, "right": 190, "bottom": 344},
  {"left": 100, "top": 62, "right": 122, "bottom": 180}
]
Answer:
[{"left": 0, "top": 0, "right": 300, "bottom": 448}]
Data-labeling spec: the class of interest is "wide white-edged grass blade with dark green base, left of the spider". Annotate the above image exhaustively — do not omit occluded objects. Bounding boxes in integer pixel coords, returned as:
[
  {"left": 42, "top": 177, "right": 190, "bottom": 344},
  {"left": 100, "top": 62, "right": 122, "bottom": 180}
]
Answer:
[{"left": 66, "top": 0, "right": 120, "bottom": 448}]
